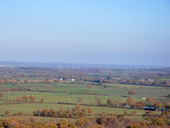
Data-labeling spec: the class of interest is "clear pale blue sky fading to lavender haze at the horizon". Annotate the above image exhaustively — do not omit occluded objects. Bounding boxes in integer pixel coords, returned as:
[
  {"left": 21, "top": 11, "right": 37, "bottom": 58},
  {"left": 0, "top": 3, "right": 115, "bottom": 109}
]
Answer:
[{"left": 0, "top": 0, "right": 170, "bottom": 66}]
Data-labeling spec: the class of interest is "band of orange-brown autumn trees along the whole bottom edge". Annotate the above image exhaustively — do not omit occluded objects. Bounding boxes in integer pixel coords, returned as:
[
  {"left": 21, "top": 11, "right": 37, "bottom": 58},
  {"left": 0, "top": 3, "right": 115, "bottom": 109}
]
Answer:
[{"left": 0, "top": 109, "right": 170, "bottom": 128}]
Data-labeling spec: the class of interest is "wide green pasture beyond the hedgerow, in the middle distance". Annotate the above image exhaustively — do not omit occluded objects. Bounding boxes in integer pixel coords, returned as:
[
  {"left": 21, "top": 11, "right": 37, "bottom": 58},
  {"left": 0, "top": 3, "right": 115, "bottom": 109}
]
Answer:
[{"left": 1, "top": 83, "right": 170, "bottom": 104}]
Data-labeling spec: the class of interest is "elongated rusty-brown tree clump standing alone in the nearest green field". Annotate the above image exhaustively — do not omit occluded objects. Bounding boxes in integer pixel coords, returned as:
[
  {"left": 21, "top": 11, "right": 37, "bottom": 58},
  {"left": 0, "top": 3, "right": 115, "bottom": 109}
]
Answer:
[{"left": 33, "top": 105, "right": 93, "bottom": 118}]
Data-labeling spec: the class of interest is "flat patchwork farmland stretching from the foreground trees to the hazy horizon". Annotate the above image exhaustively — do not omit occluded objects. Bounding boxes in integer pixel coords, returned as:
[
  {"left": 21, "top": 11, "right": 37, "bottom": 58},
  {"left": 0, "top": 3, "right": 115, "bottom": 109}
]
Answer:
[{"left": 0, "top": 67, "right": 170, "bottom": 126}]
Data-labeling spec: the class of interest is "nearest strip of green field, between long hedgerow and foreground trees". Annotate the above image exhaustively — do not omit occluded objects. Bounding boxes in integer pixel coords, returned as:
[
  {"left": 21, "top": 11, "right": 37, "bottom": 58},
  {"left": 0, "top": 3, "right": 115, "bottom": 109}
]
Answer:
[{"left": 0, "top": 103, "right": 144, "bottom": 120}]
